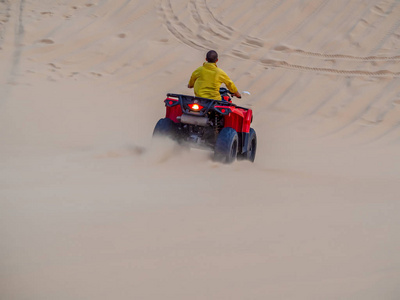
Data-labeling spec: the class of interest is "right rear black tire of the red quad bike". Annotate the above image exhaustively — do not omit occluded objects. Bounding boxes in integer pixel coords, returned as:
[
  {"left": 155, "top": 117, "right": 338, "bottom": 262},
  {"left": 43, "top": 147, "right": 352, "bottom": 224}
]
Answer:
[{"left": 214, "top": 127, "right": 239, "bottom": 164}]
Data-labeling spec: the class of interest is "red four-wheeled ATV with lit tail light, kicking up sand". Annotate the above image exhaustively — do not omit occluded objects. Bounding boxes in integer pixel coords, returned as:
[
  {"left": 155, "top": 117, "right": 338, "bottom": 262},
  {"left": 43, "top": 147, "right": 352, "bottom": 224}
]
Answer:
[{"left": 153, "top": 88, "right": 257, "bottom": 163}]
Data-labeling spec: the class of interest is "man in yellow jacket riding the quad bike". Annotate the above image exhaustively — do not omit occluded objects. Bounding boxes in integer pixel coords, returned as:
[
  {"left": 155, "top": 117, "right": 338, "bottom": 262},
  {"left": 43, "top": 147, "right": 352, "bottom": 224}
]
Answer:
[{"left": 188, "top": 50, "right": 242, "bottom": 100}]
